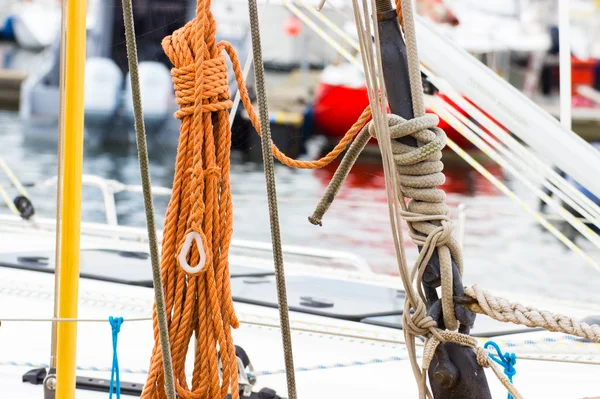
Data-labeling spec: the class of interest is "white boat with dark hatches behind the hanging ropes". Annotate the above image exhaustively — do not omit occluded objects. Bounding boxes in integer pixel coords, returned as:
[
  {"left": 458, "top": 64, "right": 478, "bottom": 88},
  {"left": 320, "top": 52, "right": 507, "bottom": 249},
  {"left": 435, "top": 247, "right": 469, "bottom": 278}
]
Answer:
[{"left": 0, "top": 190, "right": 600, "bottom": 399}]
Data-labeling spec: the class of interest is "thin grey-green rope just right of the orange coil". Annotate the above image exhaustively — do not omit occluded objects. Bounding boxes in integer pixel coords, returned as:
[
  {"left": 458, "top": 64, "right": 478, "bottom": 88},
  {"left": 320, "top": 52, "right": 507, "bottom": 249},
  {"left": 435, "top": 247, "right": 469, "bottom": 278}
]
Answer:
[{"left": 248, "top": 0, "right": 297, "bottom": 399}]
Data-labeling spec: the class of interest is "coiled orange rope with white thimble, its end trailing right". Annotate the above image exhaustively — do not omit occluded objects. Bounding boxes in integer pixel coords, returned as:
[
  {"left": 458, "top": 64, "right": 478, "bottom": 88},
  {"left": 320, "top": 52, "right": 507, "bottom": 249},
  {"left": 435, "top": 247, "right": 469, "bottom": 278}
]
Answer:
[{"left": 141, "top": 0, "right": 371, "bottom": 399}]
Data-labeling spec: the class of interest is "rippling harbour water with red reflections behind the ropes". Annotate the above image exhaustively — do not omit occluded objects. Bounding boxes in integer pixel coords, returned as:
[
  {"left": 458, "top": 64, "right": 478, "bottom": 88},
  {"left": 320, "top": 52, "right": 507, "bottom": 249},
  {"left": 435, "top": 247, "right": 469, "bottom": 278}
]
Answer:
[{"left": 0, "top": 113, "right": 600, "bottom": 301}]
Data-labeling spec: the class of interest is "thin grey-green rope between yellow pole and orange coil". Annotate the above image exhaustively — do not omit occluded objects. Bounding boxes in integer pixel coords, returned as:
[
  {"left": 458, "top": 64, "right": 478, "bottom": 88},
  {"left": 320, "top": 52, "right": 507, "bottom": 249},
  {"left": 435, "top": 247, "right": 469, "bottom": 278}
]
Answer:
[{"left": 123, "top": 0, "right": 176, "bottom": 399}]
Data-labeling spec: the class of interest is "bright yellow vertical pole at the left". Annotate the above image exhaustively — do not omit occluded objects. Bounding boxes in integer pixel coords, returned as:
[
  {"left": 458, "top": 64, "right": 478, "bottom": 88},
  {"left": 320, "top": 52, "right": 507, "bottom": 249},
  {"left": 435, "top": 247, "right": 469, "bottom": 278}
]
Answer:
[{"left": 56, "top": 0, "right": 87, "bottom": 399}]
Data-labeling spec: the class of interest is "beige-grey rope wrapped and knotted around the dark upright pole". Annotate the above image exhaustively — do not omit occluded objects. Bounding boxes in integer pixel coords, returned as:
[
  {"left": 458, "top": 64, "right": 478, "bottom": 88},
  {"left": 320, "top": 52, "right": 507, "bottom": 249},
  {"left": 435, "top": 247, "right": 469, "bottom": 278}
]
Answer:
[{"left": 309, "top": 0, "right": 510, "bottom": 398}]
